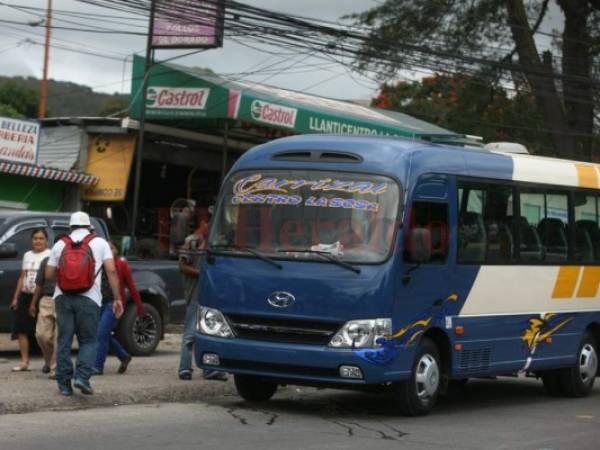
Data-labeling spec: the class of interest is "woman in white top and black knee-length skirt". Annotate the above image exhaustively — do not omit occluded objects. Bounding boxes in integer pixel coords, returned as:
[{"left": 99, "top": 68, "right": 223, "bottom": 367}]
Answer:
[{"left": 10, "top": 228, "right": 50, "bottom": 372}]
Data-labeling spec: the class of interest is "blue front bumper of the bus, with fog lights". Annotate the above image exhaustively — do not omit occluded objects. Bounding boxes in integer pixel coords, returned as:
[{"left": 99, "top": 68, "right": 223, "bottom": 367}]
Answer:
[{"left": 194, "top": 333, "right": 410, "bottom": 386}]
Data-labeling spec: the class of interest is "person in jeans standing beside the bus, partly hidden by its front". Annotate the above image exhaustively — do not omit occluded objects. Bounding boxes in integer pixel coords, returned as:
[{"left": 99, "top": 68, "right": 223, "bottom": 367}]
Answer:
[{"left": 179, "top": 216, "right": 227, "bottom": 380}]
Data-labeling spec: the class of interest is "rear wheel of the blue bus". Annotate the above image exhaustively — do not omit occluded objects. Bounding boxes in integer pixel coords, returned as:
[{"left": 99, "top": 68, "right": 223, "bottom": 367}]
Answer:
[{"left": 560, "top": 332, "right": 598, "bottom": 397}]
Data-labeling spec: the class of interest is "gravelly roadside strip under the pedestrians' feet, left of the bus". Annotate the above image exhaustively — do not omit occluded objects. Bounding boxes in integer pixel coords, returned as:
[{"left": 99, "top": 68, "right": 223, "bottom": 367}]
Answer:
[{"left": 0, "top": 334, "right": 235, "bottom": 414}]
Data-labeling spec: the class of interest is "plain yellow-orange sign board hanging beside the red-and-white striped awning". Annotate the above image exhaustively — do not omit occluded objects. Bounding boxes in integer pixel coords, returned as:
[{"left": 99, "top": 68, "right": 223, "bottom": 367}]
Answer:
[{"left": 81, "top": 134, "right": 135, "bottom": 202}]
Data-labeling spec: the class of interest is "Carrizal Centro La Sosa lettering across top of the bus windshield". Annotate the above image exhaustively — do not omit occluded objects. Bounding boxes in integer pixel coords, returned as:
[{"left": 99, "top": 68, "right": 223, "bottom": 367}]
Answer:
[{"left": 231, "top": 173, "right": 388, "bottom": 212}]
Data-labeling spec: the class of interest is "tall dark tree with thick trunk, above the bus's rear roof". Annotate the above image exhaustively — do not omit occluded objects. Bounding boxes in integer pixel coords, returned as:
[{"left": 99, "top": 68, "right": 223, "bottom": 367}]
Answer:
[{"left": 351, "top": 0, "right": 600, "bottom": 160}]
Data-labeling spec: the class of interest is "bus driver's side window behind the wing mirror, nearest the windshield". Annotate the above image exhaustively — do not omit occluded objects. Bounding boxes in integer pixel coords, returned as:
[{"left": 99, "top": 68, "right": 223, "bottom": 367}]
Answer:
[{"left": 404, "top": 201, "right": 449, "bottom": 264}]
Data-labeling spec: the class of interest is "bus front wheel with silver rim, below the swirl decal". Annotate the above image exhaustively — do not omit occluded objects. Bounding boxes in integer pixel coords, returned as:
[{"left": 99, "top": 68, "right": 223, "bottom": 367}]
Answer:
[{"left": 393, "top": 337, "right": 442, "bottom": 416}]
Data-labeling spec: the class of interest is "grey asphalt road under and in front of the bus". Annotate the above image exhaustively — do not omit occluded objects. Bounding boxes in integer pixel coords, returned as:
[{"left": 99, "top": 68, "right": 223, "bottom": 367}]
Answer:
[{"left": 0, "top": 379, "right": 600, "bottom": 450}]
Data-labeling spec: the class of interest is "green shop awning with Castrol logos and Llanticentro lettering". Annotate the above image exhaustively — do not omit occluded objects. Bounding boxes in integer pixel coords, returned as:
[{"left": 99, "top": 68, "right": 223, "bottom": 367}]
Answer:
[{"left": 131, "top": 56, "right": 462, "bottom": 140}]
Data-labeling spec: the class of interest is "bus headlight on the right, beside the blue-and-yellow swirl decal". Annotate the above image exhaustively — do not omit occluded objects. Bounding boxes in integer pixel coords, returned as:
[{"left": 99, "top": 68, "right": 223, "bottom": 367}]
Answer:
[{"left": 329, "top": 319, "right": 392, "bottom": 348}]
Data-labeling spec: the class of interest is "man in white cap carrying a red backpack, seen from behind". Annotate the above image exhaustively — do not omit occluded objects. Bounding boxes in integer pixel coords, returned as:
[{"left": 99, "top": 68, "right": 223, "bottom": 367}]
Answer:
[{"left": 46, "top": 211, "right": 123, "bottom": 396}]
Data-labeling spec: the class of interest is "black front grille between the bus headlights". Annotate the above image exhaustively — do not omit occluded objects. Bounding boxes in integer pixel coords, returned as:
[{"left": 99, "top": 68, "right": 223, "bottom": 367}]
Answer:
[{"left": 227, "top": 314, "right": 343, "bottom": 345}]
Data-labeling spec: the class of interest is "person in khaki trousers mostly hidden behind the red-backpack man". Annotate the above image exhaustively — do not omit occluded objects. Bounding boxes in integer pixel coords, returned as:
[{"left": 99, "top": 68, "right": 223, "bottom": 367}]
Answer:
[{"left": 29, "top": 235, "right": 64, "bottom": 379}]
